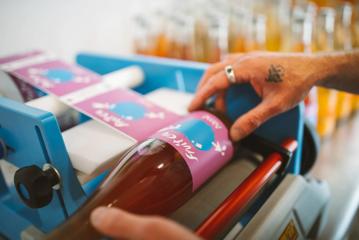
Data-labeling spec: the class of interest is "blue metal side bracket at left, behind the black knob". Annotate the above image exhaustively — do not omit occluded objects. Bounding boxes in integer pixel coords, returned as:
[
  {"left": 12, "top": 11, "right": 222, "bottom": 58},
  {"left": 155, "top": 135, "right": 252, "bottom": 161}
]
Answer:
[{"left": 0, "top": 98, "right": 85, "bottom": 236}]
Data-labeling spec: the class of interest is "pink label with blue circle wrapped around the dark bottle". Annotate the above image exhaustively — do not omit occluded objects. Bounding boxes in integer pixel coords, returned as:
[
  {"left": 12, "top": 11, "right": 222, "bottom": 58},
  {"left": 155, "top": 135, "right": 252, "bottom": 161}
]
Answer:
[{"left": 153, "top": 111, "right": 233, "bottom": 191}]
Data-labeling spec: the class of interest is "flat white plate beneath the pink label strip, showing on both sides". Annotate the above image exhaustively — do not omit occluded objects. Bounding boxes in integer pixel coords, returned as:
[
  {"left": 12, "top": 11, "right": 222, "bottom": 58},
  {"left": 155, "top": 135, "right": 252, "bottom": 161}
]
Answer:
[{"left": 62, "top": 88, "right": 193, "bottom": 175}]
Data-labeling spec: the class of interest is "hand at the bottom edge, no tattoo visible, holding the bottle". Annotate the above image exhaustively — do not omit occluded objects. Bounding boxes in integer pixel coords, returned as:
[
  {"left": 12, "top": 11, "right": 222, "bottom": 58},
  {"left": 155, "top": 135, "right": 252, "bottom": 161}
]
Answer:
[{"left": 91, "top": 207, "right": 200, "bottom": 240}]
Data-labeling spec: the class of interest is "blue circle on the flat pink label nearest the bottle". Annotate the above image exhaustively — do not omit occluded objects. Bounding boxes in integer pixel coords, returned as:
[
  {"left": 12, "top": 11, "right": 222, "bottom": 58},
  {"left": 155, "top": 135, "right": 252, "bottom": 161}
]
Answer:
[{"left": 111, "top": 102, "right": 146, "bottom": 120}]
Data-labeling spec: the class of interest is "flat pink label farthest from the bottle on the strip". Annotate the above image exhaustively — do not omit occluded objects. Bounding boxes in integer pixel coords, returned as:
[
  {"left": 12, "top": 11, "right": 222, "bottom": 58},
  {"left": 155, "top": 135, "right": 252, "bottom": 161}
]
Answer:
[{"left": 11, "top": 61, "right": 101, "bottom": 96}]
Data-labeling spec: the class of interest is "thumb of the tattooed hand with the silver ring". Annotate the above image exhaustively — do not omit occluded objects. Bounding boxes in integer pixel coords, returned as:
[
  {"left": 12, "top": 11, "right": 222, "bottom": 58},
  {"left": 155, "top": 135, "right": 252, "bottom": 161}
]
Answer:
[{"left": 230, "top": 101, "right": 282, "bottom": 141}]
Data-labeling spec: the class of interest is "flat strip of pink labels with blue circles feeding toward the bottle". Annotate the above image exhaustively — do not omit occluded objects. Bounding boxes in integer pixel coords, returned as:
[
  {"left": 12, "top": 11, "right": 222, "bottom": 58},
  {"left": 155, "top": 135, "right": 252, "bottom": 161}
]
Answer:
[{"left": 0, "top": 50, "right": 180, "bottom": 141}]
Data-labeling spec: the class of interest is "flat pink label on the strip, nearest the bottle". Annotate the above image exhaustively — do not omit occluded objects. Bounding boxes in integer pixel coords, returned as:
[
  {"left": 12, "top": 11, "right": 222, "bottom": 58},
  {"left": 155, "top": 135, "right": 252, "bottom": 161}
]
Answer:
[{"left": 74, "top": 89, "right": 179, "bottom": 141}]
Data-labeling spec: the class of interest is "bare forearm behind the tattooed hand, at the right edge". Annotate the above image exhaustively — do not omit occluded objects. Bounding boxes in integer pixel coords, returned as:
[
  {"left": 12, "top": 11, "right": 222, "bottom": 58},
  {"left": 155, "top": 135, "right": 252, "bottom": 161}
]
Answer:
[{"left": 315, "top": 50, "right": 359, "bottom": 94}]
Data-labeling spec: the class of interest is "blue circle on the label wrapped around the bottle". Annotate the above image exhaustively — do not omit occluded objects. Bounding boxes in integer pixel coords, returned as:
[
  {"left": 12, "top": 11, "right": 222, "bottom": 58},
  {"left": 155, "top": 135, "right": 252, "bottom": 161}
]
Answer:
[{"left": 176, "top": 119, "right": 215, "bottom": 151}]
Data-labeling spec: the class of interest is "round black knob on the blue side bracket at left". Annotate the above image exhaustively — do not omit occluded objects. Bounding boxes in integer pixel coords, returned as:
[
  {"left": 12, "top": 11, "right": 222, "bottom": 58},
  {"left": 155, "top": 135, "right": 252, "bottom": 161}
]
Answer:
[{"left": 14, "top": 165, "right": 60, "bottom": 208}]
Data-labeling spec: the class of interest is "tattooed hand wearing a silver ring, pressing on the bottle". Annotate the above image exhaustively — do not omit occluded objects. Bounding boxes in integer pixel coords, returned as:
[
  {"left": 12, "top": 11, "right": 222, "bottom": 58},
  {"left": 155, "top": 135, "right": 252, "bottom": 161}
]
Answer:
[{"left": 189, "top": 52, "right": 319, "bottom": 141}]
